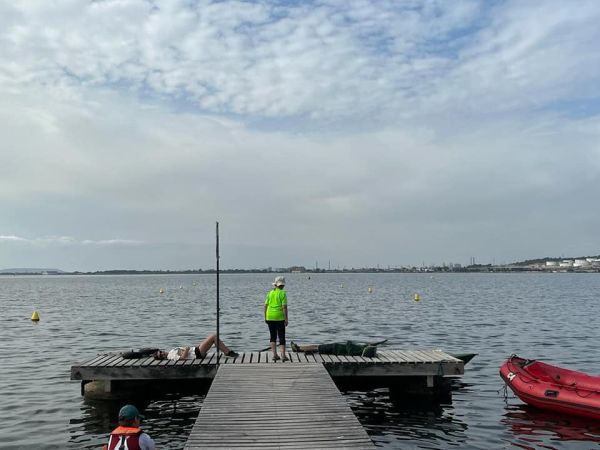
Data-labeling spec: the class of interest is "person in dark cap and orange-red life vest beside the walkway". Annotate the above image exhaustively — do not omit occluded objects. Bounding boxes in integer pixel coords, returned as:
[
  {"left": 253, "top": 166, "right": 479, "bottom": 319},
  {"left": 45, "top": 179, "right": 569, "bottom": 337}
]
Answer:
[{"left": 102, "top": 405, "right": 155, "bottom": 450}]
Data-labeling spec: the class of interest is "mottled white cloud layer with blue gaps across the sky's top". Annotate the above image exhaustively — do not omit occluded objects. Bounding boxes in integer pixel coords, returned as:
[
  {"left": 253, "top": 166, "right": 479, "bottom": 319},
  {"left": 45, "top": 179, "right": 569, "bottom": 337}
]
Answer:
[{"left": 0, "top": 1, "right": 600, "bottom": 120}]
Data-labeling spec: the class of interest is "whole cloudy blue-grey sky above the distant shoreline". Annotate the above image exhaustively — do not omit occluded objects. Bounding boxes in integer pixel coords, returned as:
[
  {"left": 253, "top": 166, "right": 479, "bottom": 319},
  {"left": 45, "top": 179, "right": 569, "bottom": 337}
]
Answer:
[{"left": 0, "top": 0, "right": 600, "bottom": 271}]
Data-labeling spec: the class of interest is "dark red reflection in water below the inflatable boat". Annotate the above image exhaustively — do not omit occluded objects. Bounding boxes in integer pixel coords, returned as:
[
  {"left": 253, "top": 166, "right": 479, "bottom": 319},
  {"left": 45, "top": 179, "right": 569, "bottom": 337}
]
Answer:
[{"left": 502, "top": 405, "right": 600, "bottom": 449}]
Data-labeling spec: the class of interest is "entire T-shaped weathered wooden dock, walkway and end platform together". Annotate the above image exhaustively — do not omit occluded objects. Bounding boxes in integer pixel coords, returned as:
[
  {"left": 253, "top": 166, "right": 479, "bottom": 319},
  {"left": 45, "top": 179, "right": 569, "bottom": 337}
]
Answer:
[{"left": 71, "top": 350, "right": 464, "bottom": 450}]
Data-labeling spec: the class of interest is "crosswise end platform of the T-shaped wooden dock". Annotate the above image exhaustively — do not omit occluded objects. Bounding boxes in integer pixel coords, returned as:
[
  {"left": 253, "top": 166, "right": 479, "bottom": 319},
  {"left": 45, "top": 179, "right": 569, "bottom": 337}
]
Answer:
[{"left": 71, "top": 350, "right": 464, "bottom": 382}]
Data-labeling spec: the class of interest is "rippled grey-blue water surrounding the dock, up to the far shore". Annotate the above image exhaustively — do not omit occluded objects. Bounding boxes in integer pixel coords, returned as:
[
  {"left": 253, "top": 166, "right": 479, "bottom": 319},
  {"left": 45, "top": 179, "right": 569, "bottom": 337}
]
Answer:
[{"left": 0, "top": 273, "right": 600, "bottom": 449}]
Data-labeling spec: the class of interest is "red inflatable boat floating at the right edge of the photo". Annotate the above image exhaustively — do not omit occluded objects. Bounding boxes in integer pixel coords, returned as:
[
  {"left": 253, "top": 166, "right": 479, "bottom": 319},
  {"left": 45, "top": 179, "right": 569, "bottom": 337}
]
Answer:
[{"left": 500, "top": 355, "right": 600, "bottom": 420}]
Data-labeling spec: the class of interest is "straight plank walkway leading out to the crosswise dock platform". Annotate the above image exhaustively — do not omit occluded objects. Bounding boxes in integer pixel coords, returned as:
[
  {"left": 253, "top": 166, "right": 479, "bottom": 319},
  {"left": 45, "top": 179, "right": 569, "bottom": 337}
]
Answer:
[{"left": 185, "top": 363, "right": 375, "bottom": 450}]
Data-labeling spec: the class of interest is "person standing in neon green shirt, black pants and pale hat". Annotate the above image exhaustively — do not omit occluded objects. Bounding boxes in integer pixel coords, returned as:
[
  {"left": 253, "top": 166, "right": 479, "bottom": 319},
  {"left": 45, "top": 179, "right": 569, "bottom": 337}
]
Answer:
[{"left": 264, "top": 276, "right": 288, "bottom": 361}]
